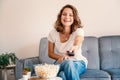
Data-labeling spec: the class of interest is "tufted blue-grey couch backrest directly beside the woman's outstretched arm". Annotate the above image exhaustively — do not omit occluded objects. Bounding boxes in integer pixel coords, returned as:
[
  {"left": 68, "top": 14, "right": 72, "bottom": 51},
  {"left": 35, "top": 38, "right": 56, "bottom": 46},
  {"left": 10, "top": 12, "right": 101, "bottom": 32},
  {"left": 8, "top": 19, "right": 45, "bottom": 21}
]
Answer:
[{"left": 82, "top": 36, "right": 100, "bottom": 69}]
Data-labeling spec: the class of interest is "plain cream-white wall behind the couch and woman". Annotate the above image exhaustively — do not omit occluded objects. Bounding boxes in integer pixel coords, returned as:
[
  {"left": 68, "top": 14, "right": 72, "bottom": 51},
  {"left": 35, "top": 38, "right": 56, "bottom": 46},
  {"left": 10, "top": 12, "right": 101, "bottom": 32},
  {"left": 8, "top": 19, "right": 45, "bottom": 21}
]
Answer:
[{"left": 0, "top": 0, "right": 120, "bottom": 58}]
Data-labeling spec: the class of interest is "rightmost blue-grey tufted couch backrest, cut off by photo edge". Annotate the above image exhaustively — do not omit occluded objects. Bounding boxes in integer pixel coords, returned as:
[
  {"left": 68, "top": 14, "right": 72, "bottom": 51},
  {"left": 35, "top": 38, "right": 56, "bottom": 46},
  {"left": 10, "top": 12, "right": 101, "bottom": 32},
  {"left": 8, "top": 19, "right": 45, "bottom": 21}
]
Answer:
[{"left": 99, "top": 36, "right": 120, "bottom": 69}]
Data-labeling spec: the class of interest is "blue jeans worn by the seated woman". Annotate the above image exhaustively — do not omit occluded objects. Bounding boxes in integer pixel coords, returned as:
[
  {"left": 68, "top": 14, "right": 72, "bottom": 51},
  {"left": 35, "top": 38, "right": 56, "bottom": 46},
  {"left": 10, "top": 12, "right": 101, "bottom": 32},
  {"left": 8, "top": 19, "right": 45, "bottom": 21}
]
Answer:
[{"left": 54, "top": 60, "right": 86, "bottom": 80}]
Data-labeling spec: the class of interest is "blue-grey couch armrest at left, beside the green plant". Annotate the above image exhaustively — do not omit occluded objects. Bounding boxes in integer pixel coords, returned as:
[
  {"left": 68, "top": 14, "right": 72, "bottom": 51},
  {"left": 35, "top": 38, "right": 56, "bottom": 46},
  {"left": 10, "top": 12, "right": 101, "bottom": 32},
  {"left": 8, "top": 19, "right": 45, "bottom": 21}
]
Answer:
[{"left": 15, "top": 57, "right": 40, "bottom": 80}]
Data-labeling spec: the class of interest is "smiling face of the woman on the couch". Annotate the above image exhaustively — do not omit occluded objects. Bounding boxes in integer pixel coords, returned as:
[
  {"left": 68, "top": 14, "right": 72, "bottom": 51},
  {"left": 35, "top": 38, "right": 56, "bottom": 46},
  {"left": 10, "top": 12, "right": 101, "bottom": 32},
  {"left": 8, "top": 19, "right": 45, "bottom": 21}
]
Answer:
[{"left": 61, "top": 8, "right": 74, "bottom": 27}]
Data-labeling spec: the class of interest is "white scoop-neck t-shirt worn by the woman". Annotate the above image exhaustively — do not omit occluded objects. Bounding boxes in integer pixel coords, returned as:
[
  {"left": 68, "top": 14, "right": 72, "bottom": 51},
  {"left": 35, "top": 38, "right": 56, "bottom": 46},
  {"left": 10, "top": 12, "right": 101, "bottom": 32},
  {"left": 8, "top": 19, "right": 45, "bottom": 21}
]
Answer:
[{"left": 48, "top": 28, "right": 88, "bottom": 65}]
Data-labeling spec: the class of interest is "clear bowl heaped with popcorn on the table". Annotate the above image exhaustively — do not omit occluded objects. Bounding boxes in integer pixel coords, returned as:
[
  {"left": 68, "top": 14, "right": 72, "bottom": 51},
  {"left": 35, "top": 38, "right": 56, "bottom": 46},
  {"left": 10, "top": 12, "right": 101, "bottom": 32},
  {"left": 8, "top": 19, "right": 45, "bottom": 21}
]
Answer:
[{"left": 35, "top": 64, "right": 59, "bottom": 78}]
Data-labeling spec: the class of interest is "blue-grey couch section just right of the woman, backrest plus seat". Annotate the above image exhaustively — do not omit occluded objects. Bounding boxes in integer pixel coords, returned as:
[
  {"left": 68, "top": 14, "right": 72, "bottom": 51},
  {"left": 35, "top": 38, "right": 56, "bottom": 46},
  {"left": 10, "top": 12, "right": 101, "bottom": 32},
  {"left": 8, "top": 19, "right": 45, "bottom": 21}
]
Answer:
[{"left": 80, "top": 36, "right": 110, "bottom": 80}]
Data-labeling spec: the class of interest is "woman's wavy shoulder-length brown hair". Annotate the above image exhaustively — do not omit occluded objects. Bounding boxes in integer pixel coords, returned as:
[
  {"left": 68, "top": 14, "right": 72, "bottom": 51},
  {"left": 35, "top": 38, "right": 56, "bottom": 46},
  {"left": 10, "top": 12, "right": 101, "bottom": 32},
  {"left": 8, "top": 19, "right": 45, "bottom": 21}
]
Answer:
[{"left": 54, "top": 4, "right": 83, "bottom": 33}]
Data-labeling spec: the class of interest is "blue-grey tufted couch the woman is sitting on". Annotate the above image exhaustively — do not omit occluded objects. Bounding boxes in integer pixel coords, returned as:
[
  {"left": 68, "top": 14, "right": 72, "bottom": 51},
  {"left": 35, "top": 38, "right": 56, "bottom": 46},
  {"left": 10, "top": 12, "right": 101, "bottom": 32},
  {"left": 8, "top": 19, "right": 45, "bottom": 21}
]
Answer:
[{"left": 16, "top": 35, "right": 120, "bottom": 80}]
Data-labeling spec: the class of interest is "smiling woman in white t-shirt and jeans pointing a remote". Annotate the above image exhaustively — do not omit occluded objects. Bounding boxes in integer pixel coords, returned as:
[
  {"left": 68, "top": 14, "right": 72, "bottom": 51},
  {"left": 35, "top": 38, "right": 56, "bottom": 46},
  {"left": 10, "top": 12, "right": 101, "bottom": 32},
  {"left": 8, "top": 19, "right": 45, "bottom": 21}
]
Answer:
[{"left": 48, "top": 4, "right": 87, "bottom": 80}]
